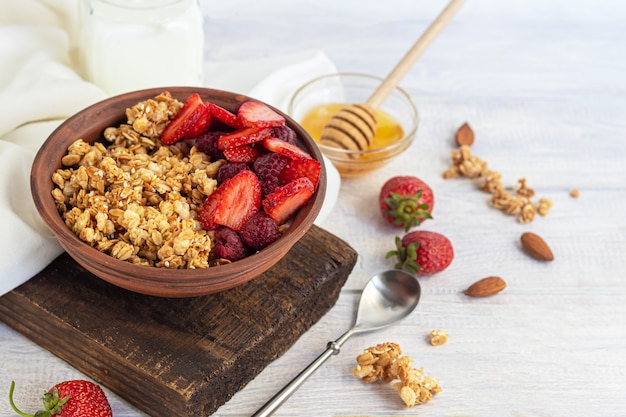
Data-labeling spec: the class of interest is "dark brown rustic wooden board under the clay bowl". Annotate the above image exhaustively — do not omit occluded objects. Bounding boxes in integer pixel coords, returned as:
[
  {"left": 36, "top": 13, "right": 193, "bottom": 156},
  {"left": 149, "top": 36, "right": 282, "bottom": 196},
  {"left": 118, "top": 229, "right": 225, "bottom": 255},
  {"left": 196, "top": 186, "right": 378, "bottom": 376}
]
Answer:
[{"left": 0, "top": 226, "right": 357, "bottom": 417}]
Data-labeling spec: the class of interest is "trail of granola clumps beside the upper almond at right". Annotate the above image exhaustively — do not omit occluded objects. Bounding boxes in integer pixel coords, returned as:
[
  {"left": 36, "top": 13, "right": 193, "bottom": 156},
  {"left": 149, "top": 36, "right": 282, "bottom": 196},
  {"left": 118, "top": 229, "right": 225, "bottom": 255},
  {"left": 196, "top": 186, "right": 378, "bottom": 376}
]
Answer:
[{"left": 443, "top": 145, "right": 552, "bottom": 223}]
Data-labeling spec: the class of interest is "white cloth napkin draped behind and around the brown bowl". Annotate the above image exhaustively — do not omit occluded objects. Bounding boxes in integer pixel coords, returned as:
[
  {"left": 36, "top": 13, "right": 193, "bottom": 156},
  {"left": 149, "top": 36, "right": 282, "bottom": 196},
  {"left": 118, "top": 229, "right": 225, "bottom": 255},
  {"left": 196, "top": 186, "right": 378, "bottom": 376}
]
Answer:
[{"left": 0, "top": 0, "right": 339, "bottom": 295}]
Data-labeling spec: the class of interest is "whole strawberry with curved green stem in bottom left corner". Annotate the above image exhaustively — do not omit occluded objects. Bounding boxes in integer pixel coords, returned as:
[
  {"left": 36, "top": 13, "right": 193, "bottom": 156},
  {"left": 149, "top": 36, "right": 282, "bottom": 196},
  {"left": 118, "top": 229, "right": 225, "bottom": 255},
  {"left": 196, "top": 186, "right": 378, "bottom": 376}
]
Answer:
[{"left": 9, "top": 380, "right": 113, "bottom": 417}]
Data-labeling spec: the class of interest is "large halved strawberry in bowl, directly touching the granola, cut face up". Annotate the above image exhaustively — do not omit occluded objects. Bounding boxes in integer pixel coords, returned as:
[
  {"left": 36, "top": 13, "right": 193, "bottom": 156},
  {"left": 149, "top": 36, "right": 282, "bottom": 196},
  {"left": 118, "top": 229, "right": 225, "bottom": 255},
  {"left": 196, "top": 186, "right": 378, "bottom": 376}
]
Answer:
[{"left": 198, "top": 170, "right": 261, "bottom": 232}]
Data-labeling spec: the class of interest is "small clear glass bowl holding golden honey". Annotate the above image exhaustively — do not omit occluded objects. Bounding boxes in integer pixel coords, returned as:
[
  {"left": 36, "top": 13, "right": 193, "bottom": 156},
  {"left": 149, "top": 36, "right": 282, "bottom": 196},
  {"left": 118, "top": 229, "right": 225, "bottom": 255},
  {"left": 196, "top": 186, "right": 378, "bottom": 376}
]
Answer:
[{"left": 288, "top": 73, "right": 419, "bottom": 177}]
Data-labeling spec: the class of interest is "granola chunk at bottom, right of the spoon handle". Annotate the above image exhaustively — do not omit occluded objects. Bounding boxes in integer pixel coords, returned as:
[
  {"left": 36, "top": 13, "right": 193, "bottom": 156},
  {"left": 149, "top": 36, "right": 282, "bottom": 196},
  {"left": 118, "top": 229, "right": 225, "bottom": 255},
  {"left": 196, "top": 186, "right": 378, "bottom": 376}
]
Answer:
[{"left": 352, "top": 342, "right": 441, "bottom": 407}]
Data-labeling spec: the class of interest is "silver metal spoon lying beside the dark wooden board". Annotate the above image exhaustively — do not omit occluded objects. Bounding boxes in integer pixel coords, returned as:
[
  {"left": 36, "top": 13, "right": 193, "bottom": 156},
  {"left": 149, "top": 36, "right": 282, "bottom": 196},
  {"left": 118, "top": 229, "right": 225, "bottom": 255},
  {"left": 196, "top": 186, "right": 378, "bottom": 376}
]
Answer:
[{"left": 253, "top": 269, "right": 421, "bottom": 417}]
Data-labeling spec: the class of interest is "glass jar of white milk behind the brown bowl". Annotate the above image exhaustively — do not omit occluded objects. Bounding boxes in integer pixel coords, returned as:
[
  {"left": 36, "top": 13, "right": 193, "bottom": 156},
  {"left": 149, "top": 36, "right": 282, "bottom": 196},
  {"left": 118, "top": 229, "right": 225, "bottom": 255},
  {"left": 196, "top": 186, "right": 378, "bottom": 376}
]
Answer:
[{"left": 78, "top": 0, "right": 204, "bottom": 95}]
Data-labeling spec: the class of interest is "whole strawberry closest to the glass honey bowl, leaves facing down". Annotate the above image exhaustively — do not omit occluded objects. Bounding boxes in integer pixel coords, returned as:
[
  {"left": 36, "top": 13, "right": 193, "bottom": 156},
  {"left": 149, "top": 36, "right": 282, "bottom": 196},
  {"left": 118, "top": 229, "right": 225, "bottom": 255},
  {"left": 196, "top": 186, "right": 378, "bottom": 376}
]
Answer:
[{"left": 378, "top": 175, "right": 435, "bottom": 232}]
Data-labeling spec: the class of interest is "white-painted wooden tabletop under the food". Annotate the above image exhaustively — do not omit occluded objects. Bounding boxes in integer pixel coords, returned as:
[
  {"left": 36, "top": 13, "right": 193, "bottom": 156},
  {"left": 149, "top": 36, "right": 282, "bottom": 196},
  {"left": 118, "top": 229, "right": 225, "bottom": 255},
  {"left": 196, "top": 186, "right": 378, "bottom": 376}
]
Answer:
[{"left": 0, "top": 0, "right": 626, "bottom": 417}]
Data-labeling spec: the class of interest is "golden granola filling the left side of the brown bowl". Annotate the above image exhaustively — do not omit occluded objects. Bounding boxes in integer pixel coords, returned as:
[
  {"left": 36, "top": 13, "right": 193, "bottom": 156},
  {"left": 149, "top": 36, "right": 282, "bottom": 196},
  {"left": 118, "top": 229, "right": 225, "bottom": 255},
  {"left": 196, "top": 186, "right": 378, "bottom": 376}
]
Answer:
[{"left": 52, "top": 94, "right": 223, "bottom": 269}]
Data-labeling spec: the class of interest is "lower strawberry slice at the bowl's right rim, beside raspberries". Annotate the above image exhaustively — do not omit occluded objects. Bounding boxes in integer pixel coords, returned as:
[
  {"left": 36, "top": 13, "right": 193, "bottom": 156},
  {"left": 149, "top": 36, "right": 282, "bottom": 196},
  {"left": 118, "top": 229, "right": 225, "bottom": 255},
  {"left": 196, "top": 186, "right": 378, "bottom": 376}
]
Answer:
[{"left": 261, "top": 177, "right": 315, "bottom": 225}]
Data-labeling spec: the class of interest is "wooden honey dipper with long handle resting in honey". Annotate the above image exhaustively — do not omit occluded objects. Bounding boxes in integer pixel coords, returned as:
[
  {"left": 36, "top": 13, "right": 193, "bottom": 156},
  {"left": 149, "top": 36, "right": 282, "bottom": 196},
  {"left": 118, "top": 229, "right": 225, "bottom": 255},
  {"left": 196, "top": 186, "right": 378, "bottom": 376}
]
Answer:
[{"left": 320, "top": 0, "right": 465, "bottom": 150}]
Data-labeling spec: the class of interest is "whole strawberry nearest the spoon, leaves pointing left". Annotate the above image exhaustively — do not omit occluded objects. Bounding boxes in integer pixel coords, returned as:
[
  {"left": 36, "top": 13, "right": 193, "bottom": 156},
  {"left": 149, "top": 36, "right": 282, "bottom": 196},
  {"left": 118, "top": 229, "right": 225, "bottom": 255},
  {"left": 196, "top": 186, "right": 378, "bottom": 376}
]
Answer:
[{"left": 387, "top": 230, "right": 454, "bottom": 275}]
